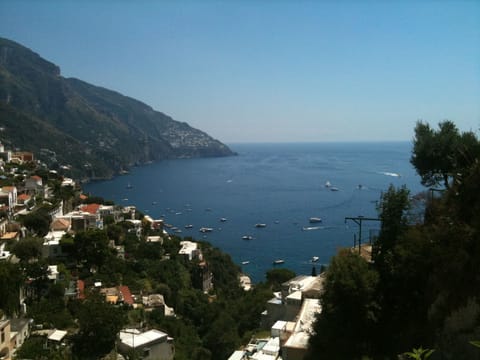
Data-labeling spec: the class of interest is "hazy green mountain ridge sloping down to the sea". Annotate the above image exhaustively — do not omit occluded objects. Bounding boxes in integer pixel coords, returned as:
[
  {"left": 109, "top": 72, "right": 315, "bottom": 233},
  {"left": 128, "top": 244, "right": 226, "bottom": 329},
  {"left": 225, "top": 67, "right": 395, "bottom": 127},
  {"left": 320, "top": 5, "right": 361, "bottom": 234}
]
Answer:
[{"left": 0, "top": 38, "right": 234, "bottom": 178}]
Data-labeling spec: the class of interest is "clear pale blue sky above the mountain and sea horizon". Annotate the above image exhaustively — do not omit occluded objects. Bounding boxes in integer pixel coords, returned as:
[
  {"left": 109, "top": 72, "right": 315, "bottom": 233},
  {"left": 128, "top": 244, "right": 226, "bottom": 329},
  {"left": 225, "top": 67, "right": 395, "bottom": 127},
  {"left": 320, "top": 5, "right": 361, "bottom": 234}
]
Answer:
[{"left": 0, "top": 0, "right": 480, "bottom": 143}]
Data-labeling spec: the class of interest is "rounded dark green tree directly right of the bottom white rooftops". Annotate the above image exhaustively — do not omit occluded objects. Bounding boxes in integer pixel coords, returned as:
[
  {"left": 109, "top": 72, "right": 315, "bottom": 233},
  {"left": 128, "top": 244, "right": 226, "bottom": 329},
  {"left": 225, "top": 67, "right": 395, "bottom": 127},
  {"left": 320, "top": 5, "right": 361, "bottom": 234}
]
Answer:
[{"left": 307, "top": 249, "right": 379, "bottom": 360}]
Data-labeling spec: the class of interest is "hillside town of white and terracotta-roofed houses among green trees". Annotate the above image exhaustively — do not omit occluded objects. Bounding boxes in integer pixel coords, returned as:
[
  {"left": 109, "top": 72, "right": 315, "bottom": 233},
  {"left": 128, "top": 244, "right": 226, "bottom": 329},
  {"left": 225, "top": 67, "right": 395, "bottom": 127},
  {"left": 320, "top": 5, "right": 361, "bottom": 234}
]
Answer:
[{"left": 0, "top": 141, "right": 324, "bottom": 360}]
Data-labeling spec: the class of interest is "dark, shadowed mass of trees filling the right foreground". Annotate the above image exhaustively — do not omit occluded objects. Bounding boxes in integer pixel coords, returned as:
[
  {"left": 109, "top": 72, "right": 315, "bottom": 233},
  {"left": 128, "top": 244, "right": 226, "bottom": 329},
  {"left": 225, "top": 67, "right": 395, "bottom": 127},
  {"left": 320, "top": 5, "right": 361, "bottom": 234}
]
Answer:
[{"left": 309, "top": 121, "right": 480, "bottom": 360}]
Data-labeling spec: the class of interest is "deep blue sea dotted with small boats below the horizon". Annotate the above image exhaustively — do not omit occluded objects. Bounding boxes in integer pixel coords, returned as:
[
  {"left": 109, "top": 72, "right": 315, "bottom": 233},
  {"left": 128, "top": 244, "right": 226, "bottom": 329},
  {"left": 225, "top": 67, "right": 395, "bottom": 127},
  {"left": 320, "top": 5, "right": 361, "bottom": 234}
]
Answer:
[{"left": 84, "top": 142, "right": 424, "bottom": 282}]
